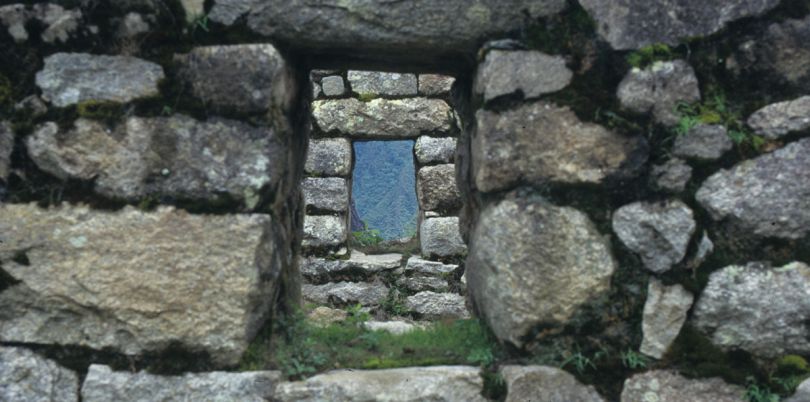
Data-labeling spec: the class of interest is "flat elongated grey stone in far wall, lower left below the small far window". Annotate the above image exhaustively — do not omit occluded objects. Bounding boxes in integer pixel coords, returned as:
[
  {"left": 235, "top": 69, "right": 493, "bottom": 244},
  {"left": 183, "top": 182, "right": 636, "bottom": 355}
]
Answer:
[{"left": 301, "top": 282, "right": 388, "bottom": 307}]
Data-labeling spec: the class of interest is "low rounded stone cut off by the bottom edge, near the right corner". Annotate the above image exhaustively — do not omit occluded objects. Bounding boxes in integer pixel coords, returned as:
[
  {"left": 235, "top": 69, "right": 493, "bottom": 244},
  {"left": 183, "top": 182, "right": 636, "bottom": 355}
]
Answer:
[{"left": 621, "top": 370, "right": 746, "bottom": 402}]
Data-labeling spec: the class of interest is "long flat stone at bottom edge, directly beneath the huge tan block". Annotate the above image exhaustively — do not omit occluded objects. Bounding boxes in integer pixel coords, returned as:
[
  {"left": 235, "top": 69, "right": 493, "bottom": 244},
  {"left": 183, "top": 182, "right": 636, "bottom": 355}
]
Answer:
[{"left": 82, "top": 364, "right": 282, "bottom": 402}]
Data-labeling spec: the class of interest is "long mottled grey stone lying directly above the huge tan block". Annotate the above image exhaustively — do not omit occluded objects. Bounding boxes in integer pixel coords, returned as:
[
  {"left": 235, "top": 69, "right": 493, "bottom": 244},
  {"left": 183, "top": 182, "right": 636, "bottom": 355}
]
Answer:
[{"left": 26, "top": 115, "right": 289, "bottom": 208}]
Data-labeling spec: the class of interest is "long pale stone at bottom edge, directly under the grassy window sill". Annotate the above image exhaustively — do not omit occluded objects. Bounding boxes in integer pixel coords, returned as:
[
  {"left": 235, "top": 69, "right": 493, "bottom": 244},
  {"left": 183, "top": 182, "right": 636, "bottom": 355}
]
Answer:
[{"left": 275, "top": 366, "right": 486, "bottom": 402}]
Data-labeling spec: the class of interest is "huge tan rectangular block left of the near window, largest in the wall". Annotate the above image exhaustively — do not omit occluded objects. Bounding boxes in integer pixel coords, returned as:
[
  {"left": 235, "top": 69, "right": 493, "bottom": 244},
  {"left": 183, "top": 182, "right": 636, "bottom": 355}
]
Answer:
[{"left": 0, "top": 204, "right": 284, "bottom": 365}]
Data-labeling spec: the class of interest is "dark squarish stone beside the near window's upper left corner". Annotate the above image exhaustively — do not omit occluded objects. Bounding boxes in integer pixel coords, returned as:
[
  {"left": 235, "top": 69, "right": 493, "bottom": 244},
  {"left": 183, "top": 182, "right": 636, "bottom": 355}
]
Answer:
[{"left": 174, "top": 44, "right": 297, "bottom": 114}]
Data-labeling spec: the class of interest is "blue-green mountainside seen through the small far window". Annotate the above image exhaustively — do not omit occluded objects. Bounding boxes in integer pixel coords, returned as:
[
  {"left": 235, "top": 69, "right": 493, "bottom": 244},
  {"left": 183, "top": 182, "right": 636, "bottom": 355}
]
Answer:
[{"left": 352, "top": 141, "right": 419, "bottom": 240}]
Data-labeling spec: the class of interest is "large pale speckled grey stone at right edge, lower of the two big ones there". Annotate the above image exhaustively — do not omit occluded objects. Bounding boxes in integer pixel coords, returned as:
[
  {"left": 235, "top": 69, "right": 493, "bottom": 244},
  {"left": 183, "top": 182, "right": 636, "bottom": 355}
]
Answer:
[{"left": 693, "top": 262, "right": 810, "bottom": 358}]
